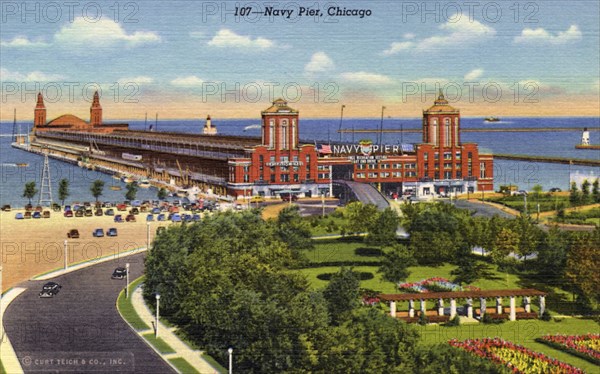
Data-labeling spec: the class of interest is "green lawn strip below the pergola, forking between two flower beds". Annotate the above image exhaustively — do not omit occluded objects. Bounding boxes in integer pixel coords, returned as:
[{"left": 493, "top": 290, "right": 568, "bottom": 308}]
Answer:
[{"left": 415, "top": 318, "right": 600, "bottom": 373}]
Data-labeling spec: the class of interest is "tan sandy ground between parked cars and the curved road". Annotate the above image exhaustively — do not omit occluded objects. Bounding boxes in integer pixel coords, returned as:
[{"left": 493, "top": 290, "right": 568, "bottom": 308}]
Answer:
[{"left": 0, "top": 209, "right": 169, "bottom": 290}]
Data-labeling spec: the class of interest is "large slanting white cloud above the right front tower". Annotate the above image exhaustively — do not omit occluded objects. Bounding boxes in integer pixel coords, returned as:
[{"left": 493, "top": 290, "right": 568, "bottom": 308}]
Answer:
[{"left": 383, "top": 15, "right": 496, "bottom": 55}]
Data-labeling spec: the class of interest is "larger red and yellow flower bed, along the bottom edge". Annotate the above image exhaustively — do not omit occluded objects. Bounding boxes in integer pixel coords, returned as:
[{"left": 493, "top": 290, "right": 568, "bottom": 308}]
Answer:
[{"left": 449, "top": 338, "right": 584, "bottom": 374}]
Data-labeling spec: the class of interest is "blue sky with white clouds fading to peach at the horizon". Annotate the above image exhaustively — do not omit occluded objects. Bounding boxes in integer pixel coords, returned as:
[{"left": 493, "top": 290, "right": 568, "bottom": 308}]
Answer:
[{"left": 0, "top": 0, "right": 600, "bottom": 121}]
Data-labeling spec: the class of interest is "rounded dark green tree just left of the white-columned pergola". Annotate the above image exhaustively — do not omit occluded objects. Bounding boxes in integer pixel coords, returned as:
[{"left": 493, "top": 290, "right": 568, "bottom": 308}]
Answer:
[{"left": 323, "top": 267, "right": 360, "bottom": 324}]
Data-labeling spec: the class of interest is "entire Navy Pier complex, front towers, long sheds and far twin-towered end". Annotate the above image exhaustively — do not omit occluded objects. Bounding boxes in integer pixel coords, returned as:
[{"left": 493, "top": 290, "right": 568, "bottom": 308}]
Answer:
[{"left": 24, "top": 93, "right": 493, "bottom": 197}]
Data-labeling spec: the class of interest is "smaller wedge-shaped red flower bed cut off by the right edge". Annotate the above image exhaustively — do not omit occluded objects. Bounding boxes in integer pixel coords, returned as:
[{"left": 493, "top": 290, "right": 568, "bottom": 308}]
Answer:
[{"left": 536, "top": 334, "right": 600, "bottom": 365}]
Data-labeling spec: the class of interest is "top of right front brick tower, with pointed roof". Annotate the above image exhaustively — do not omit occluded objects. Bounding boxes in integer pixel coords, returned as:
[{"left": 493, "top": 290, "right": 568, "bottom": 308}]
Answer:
[{"left": 423, "top": 89, "right": 460, "bottom": 148}]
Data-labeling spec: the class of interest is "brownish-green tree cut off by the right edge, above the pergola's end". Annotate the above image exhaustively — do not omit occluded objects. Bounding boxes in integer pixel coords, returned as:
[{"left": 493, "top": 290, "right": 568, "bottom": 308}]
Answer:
[{"left": 565, "top": 227, "right": 600, "bottom": 308}]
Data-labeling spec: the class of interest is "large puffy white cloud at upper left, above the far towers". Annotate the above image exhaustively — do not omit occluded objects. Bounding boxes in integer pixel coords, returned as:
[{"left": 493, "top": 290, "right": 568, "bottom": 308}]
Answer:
[{"left": 54, "top": 17, "right": 160, "bottom": 47}]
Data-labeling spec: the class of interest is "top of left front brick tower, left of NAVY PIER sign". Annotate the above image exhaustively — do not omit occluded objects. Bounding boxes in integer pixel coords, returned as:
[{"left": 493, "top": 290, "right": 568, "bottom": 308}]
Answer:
[{"left": 261, "top": 99, "right": 298, "bottom": 150}]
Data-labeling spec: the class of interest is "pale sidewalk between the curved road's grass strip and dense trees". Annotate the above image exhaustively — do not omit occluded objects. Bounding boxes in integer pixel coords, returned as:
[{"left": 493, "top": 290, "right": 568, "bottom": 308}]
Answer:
[{"left": 131, "top": 284, "right": 219, "bottom": 374}]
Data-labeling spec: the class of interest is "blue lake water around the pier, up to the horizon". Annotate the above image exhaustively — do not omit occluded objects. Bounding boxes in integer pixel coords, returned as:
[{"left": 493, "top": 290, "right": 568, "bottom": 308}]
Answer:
[{"left": 0, "top": 117, "right": 600, "bottom": 206}]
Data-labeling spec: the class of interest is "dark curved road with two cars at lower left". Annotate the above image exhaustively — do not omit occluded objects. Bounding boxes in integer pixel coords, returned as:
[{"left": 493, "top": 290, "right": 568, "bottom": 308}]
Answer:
[{"left": 4, "top": 254, "right": 173, "bottom": 373}]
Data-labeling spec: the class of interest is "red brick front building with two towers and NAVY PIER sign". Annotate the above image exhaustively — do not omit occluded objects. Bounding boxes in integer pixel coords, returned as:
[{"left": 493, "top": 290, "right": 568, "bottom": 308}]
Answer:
[{"left": 228, "top": 92, "right": 493, "bottom": 196}]
